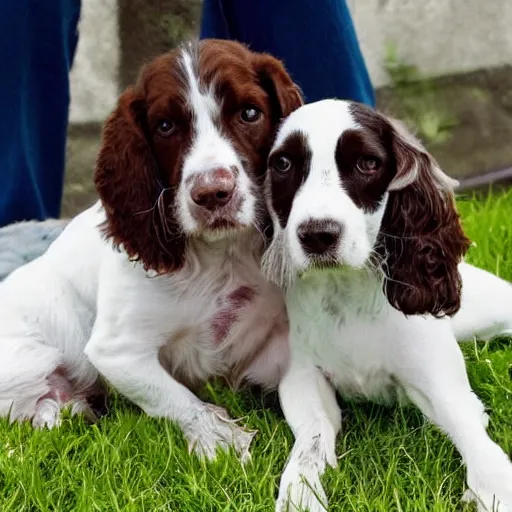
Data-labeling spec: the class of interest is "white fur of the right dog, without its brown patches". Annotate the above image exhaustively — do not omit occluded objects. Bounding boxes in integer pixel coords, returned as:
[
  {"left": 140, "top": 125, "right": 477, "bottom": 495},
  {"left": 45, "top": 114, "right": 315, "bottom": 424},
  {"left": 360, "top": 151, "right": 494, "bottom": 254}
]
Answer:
[{"left": 264, "top": 100, "right": 512, "bottom": 512}]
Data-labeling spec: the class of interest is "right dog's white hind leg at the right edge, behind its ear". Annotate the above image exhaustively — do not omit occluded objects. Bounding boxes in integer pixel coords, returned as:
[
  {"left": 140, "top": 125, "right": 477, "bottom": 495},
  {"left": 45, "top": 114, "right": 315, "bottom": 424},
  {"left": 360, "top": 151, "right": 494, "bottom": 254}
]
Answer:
[{"left": 451, "top": 263, "right": 512, "bottom": 341}]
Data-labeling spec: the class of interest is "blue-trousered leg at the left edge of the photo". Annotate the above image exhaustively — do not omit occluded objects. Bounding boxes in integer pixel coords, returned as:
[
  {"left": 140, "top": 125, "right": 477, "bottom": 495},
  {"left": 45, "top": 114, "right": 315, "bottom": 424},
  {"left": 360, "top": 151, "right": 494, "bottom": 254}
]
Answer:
[{"left": 0, "top": 0, "right": 80, "bottom": 226}]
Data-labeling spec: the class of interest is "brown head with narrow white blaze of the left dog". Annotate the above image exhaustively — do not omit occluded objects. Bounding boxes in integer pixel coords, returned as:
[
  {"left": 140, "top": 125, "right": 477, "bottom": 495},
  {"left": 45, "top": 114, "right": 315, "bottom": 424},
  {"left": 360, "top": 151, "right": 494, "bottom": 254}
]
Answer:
[{"left": 95, "top": 40, "right": 302, "bottom": 272}]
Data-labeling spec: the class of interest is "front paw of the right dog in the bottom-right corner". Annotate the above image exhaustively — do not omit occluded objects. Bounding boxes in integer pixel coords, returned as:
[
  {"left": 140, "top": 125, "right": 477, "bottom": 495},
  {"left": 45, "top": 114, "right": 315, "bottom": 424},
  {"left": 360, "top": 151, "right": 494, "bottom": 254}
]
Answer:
[{"left": 462, "top": 447, "right": 512, "bottom": 512}]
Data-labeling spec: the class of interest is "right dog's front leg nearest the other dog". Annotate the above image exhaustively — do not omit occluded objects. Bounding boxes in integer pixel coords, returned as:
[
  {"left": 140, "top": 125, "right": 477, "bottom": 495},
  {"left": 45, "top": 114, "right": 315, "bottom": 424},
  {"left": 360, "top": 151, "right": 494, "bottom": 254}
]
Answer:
[{"left": 276, "top": 362, "right": 341, "bottom": 512}]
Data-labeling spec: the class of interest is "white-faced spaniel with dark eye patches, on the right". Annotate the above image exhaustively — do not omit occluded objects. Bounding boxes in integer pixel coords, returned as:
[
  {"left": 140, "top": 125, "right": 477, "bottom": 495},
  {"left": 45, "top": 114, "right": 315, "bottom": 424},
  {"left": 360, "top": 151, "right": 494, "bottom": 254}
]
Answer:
[{"left": 262, "top": 100, "right": 512, "bottom": 512}]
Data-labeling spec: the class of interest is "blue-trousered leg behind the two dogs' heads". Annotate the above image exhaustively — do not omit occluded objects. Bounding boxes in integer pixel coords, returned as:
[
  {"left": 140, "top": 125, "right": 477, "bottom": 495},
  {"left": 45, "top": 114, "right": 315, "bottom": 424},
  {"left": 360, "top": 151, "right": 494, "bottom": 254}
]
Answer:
[{"left": 201, "top": 0, "right": 375, "bottom": 106}]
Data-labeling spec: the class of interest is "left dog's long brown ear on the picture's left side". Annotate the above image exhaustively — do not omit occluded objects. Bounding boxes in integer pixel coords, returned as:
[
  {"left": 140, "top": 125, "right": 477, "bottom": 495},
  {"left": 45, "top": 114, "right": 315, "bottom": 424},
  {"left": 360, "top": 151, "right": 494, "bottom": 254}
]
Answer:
[{"left": 94, "top": 87, "right": 185, "bottom": 272}]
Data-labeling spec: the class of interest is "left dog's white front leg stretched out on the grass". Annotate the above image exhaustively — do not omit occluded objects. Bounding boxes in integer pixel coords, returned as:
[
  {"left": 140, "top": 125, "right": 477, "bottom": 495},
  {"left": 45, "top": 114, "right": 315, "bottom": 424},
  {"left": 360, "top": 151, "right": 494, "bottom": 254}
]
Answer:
[{"left": 85, "top": 325, "right": 254, "bottom": 461}]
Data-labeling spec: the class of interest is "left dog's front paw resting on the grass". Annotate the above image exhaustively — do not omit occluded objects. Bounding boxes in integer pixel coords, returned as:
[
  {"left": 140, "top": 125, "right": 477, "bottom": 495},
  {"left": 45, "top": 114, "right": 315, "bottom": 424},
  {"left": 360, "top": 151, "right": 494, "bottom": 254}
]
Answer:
[{"left": 185, "top": 404, "right": 256, "bottom": 463}]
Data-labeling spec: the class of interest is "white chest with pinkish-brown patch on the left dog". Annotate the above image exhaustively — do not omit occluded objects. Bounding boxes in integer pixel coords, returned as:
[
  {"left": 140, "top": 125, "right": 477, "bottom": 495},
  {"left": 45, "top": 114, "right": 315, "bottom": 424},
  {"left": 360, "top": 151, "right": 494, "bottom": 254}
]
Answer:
[{"left": 161, "top": 261, "right": 288, "bottom": 387}]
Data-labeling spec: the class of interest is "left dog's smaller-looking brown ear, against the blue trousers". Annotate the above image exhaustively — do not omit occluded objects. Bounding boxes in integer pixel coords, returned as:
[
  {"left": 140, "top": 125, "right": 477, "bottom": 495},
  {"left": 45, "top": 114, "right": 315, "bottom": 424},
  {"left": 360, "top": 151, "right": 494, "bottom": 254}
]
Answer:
[{"left": 254, "top": 54, "right": 304, "bottom": 122}]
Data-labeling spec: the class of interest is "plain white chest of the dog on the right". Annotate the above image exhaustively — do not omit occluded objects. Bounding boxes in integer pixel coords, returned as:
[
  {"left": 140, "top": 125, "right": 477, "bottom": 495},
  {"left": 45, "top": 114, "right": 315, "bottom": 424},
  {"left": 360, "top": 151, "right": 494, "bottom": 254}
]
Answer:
[{"left": 287, "top": 274, "right": 400, "bottom": 401}]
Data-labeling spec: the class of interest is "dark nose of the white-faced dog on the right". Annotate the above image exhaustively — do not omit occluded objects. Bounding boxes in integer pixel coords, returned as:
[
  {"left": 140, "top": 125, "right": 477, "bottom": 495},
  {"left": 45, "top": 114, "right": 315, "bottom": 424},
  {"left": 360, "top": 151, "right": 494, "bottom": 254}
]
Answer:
[{"left": 297, "top": 219, "right": 343, "bottom": 256}]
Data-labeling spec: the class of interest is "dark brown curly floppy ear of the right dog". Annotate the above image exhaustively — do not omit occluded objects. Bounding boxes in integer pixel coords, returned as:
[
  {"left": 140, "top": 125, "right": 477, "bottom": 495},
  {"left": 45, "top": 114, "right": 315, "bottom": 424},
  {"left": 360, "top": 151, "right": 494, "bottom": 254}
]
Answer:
[{"left": 378, "top": 120, "right": 470, "bottom": 317}]
